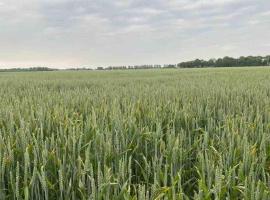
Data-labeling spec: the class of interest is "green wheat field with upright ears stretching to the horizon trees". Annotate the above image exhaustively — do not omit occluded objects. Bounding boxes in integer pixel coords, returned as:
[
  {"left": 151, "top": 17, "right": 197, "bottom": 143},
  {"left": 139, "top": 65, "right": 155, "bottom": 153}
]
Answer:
[{"left": 0, "top": 67, "right": 270, "bottom": 200}]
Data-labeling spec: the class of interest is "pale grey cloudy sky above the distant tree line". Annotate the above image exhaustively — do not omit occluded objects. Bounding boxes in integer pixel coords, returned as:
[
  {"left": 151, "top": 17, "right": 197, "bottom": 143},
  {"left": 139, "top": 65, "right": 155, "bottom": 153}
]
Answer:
[{"left": 0, "top": 0, "right": 270, "bottom": 68}]
